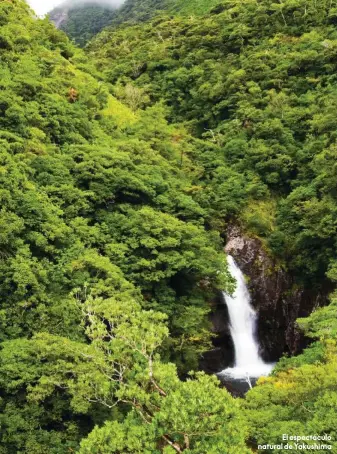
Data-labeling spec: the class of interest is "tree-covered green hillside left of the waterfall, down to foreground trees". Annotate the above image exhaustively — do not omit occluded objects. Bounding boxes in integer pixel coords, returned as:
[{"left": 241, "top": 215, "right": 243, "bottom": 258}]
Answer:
[{"left": 0, "top": 0, "right": 244, "bottom": 454}]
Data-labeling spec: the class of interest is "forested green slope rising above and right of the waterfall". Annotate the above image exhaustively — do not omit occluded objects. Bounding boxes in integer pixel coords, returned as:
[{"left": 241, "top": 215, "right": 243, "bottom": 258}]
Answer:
[{"left": 88, "top": 0, "right": 337, "bottom": 285}]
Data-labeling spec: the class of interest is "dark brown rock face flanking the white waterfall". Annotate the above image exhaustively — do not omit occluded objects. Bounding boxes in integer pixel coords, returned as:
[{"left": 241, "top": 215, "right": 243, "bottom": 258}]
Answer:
[{"left": 201, "top": 226, "right": 326, "bottom": 373}]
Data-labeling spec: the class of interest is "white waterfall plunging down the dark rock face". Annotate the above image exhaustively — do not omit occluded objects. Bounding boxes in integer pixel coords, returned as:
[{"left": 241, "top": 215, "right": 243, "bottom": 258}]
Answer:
[{"left": 220, "top": 256, "right": 273, "bottom": 379}]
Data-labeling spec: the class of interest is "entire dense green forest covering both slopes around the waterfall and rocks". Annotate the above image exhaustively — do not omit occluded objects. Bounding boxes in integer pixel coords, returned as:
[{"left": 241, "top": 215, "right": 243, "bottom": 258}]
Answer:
[{"left": 0, "top": 0, "right": 337, "bottom": 454}]
